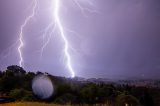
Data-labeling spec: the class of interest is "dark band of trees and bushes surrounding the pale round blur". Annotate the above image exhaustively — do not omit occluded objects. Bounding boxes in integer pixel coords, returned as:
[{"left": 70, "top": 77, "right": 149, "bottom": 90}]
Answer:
[{"left": 0, "top": 65, "right": 160, "bottom": 106}]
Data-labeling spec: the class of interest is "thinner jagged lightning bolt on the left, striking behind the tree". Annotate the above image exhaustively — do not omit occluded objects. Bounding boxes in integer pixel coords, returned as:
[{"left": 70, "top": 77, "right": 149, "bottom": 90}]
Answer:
[{"left": 18, "top": 0, "right": 38, "bottom": 67}]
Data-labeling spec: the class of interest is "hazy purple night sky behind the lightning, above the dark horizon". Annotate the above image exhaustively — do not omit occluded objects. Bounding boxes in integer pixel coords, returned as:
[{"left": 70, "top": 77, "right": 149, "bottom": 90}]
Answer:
[{"left": 0, "top": 0, "right": 160, "bottom": 79}]
